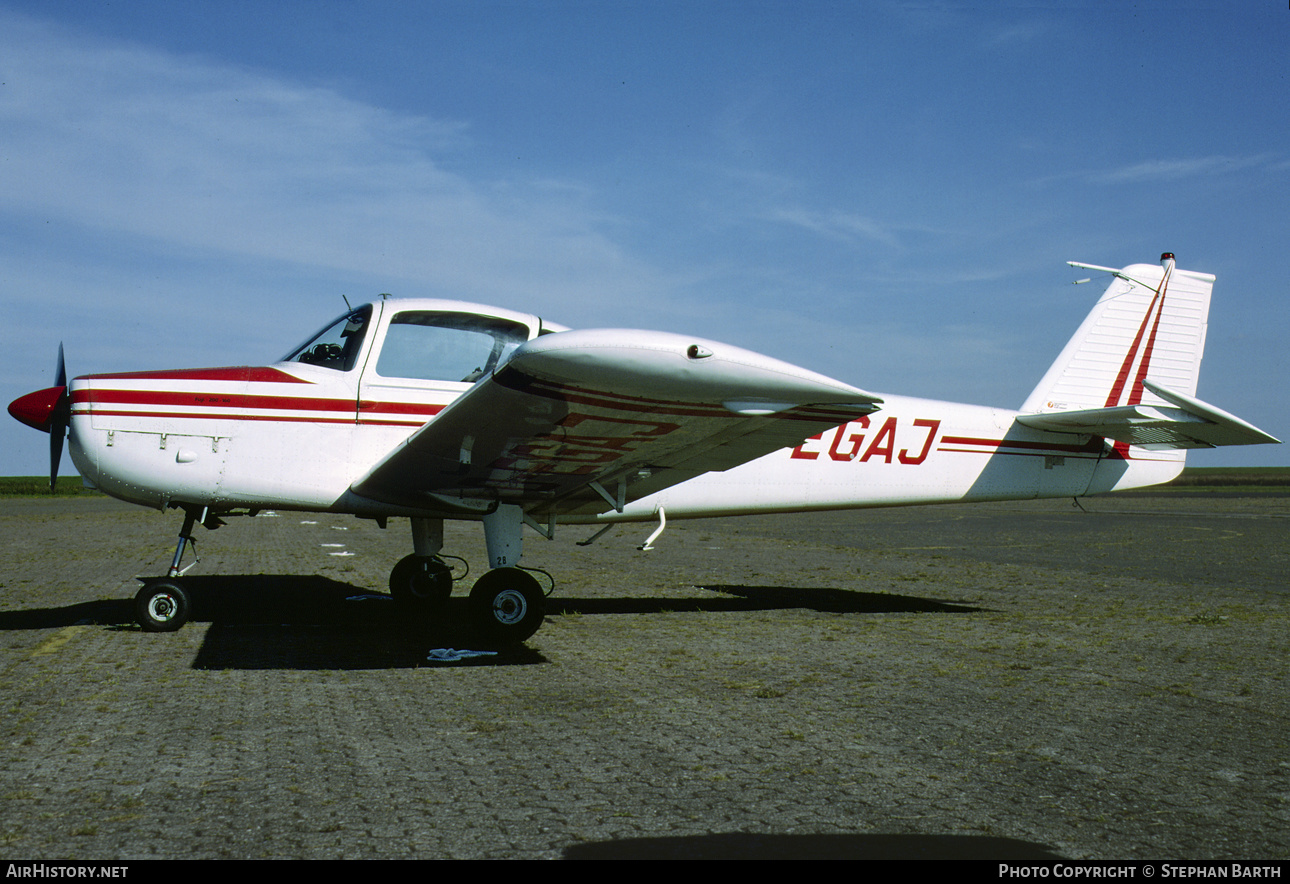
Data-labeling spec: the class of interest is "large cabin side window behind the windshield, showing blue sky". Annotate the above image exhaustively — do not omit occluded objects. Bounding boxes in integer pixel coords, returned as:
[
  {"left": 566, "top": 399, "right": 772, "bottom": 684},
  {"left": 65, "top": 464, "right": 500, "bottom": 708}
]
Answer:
[{"left": 377, "top": 310, "right": 529, "bottom": 383}]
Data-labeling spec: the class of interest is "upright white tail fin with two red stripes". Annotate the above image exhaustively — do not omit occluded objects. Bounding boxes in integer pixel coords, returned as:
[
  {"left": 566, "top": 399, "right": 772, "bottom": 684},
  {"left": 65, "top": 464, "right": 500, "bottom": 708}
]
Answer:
[{"left": 1022, "top": 252, "right": 1214, "bottom": 414}]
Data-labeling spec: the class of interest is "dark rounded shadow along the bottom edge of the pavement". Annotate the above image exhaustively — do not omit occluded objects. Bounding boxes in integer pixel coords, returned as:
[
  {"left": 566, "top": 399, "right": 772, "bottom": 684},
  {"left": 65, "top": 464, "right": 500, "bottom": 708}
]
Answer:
[{"left": 564, "top": 832, "right": 1062, "bottom": 862}]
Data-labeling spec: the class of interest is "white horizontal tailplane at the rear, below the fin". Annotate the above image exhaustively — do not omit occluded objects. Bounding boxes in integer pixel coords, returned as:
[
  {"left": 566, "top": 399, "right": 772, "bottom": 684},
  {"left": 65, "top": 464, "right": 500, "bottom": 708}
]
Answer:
[{"left": 1017, "top": 381, "right": 1280, "bottom": 450}]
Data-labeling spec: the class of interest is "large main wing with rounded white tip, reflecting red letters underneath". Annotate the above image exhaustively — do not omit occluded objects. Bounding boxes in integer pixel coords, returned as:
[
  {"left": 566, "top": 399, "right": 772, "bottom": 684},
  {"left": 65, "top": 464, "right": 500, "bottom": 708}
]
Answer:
[{"left": 352, "top": 329, "right": 881, "bottom": 515}]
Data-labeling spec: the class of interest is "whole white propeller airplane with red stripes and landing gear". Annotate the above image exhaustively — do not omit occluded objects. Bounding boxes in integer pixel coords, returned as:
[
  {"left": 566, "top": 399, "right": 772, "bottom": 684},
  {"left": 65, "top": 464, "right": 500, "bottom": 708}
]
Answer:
[{"left": 9, "top": 253, "right": 1278, "bottom": 643}]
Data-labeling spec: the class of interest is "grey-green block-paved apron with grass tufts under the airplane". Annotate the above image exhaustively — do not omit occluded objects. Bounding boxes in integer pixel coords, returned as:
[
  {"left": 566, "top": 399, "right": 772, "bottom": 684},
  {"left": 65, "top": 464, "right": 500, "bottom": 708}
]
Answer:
[{"left": 0, "top": 492, "right": 1290, "bottom": 859}]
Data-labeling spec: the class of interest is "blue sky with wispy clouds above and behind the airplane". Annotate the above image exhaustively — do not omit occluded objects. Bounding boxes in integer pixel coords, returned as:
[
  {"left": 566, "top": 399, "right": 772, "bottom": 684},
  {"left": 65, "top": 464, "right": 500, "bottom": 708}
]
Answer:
[{"left": 0, "top": 0, "right": 1290, "bottom": 475}]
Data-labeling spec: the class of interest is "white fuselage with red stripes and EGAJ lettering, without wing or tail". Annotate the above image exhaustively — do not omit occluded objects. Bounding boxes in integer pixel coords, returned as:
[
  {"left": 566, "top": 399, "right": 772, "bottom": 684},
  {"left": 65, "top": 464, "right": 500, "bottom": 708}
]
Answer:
[{"left": 71, "top": 299, "right": 1182, "bottom": 521}]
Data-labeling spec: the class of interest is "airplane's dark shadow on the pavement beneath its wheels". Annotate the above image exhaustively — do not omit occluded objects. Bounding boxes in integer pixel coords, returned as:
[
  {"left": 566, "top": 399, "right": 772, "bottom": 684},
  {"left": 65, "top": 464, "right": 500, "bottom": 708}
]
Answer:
[{"left": 0, "top": 574, "right": 980, "bottom": 670}]
